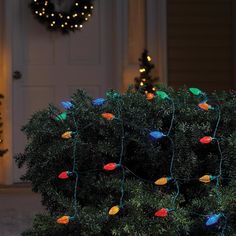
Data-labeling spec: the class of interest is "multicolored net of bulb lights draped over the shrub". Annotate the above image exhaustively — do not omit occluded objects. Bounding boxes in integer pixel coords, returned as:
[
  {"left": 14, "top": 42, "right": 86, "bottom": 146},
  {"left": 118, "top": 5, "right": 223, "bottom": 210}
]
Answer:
[{"left": 50, "top": 88, "right": 233, "bottom": 235}]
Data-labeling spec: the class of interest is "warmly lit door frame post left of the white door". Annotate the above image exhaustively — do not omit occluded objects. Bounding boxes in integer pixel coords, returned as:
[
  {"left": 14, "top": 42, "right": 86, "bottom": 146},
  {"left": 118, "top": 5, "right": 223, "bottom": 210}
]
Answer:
[{"left": 0, "top": 0, "right": 13, "bottom": 185}]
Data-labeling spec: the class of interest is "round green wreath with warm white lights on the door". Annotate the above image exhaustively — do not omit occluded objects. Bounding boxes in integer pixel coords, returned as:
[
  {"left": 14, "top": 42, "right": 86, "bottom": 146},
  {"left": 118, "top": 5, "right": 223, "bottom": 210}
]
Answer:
[{"left": 29, "top": 0, "right": 94, "bottom": 33}]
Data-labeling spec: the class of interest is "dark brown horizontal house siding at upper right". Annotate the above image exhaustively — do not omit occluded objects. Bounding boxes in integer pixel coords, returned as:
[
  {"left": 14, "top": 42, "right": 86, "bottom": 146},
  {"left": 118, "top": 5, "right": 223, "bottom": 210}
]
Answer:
[{"left": 167, "top": 0, "right": 236, "bottom": 90}]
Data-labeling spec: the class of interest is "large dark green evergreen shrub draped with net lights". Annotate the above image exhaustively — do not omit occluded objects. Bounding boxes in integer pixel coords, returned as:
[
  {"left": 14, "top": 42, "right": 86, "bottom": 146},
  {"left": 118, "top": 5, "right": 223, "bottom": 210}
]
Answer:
[{"left": 16, "top": 88, "right": 236, "bottom": 236}]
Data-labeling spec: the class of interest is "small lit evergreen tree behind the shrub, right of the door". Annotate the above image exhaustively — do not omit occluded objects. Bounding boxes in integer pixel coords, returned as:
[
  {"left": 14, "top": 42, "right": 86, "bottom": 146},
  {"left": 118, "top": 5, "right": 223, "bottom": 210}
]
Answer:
[{"left": 135, "top": 49, "right": 158, "bottom": 94}]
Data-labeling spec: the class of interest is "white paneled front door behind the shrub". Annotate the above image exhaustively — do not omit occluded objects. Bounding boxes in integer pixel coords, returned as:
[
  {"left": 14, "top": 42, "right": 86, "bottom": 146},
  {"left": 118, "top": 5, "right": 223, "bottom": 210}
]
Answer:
[{"left": 12, "top": 0, "right": 119, "bottom": 182}]
